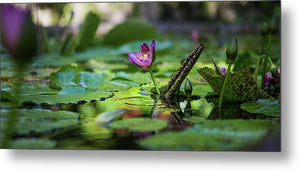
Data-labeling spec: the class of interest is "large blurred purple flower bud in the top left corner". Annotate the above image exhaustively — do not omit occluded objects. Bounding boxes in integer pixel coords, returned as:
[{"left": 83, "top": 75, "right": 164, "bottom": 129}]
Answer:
[{"left": 1, "top": 4, "right": 38, "bottom": 65}]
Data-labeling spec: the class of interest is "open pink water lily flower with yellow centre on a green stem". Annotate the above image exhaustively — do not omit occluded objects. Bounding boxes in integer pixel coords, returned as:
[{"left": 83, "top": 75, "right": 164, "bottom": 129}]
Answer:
[{"left": 128, "top": 40, "right": 155, "bottom": 70}]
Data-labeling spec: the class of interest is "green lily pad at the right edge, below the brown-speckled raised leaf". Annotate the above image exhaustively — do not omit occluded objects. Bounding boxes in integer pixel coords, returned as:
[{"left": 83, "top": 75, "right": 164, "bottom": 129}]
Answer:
[{"left": 241, "top": 99, "right": 280, "bottom": 117}]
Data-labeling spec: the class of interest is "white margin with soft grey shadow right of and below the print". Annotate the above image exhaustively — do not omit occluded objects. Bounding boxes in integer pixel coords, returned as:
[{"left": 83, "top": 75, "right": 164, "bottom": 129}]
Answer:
[{"left": 0, "top": 0, "right": 300, "bottom": 171}]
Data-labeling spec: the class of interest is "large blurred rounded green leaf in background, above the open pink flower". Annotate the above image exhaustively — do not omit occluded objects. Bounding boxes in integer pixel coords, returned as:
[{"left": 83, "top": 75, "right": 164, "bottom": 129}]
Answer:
[{"left": 103, "top": 20, "right": 157, "bottom": 46}]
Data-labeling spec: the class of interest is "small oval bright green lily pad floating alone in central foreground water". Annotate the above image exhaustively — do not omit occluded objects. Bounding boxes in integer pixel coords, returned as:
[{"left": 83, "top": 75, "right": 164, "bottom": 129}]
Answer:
[{"left": 109, "top": 118, "right": 168, "bottom": 132}]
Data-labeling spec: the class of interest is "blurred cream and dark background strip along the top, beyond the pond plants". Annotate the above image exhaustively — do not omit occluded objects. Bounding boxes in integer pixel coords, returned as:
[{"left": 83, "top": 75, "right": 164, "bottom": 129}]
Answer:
[{"left": 24, "top": 1, "right": 280, "bottom": 35}]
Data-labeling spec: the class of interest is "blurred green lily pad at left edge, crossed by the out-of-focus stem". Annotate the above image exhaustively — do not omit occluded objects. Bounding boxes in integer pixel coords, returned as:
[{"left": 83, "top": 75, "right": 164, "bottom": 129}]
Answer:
[{"left": 1, "top": 109, "right": 79, "bottom": 135}]
